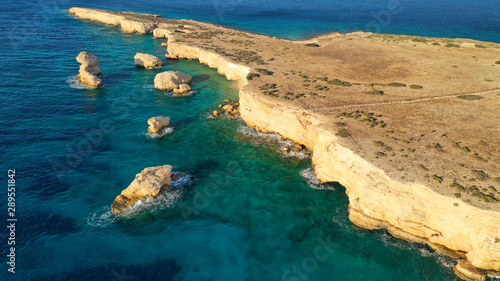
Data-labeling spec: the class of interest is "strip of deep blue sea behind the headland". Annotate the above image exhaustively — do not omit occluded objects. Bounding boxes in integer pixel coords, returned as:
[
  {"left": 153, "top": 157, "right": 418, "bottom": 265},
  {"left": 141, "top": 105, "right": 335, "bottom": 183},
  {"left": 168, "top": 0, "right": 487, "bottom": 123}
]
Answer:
[{"left": 59, "top": 0, "right": 500, "bottom": 43}]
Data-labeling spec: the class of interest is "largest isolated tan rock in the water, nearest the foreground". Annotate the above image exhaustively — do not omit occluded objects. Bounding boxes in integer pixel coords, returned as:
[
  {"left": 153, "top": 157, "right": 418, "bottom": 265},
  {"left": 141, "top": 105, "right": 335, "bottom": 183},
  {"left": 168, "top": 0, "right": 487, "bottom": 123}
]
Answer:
[{"left": 111, "top": 165, "right": 172, "bottom": 214}]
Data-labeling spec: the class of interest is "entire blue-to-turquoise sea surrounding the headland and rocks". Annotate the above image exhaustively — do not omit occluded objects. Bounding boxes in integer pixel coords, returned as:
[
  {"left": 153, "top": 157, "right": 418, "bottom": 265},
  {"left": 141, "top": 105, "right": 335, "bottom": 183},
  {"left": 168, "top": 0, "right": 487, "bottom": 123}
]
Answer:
[{"left": 0, "top": 0, "right": 500, "bottom": 281}]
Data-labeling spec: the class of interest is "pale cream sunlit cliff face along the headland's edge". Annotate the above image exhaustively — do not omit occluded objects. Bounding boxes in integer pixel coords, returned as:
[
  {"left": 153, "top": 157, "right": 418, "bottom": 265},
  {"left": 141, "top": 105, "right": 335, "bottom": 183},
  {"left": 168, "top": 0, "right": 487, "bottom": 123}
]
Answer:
[{"left": 70, "top": 9, "right": 500, "bottom": 280}]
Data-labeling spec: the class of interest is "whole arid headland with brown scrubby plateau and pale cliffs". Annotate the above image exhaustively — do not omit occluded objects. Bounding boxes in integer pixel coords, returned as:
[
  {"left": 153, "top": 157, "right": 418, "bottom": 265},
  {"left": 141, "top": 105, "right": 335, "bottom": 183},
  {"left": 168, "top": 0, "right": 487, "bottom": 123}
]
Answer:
[{"left": 69, "top": 8, "right": 500, "bottom": 280}]
